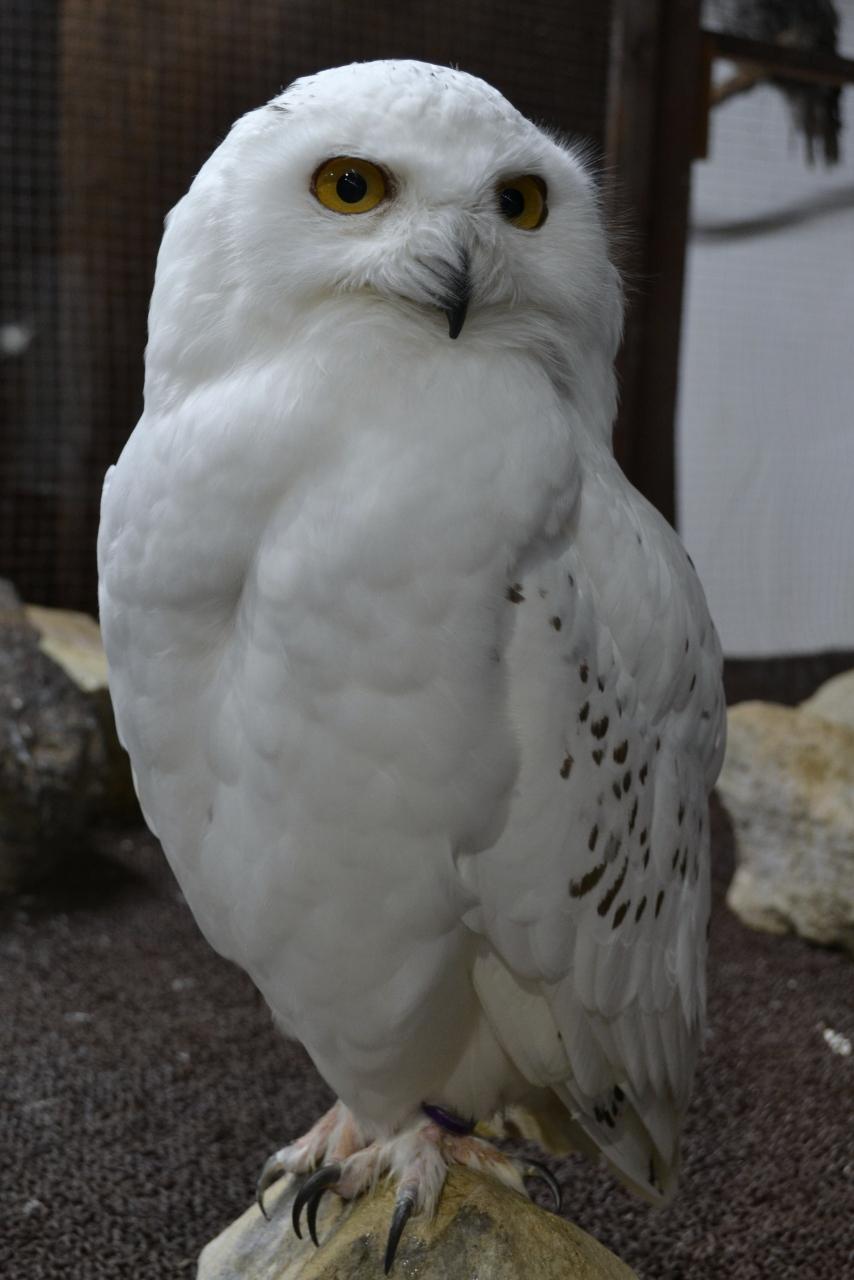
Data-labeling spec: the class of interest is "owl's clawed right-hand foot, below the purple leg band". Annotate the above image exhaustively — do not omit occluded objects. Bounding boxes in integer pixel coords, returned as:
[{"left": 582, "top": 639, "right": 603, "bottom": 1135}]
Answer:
[{"left": 292, "top": 1120, "right": 561, "bottom": 1275}]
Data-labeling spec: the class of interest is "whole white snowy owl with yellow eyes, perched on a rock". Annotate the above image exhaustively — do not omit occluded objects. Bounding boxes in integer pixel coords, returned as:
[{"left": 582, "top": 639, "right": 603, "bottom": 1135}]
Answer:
[{"left": 99, "top": 61, "right": 723, "bottom": 1270}]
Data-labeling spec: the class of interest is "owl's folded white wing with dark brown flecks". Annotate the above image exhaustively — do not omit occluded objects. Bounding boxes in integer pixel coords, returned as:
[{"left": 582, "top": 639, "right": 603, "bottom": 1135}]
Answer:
[{"left": 465, "top": 462, "right": 723, "bottom": 1202}]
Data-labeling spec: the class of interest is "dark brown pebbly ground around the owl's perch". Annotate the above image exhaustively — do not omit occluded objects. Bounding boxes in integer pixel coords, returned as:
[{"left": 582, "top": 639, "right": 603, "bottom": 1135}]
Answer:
[{"left": 0, "top": 793, "right": 854, "bottom": 1280}]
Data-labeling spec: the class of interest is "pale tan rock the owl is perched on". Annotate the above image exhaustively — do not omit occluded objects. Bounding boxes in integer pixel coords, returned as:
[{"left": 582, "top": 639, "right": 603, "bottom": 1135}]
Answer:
[{"left": 197, "top": 1167, "right": 635, "bottom": 1280}]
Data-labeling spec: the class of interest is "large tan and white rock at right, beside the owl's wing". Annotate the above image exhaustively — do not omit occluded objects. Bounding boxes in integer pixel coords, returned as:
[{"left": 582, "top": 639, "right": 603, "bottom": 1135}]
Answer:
[{"left": 718, "top": 696, "right": 854, "bottom": 954}]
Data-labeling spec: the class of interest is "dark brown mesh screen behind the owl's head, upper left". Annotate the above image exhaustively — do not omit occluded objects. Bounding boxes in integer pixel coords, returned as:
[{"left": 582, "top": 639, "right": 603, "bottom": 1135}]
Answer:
[{"left": 0, "top": 0, "right": 609, "bottom": 609}]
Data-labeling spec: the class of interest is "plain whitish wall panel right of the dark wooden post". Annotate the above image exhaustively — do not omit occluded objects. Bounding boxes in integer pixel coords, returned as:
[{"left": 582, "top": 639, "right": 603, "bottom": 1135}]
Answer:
[{"left": 677, "top": 0, "right": 854, "bottom": 655}]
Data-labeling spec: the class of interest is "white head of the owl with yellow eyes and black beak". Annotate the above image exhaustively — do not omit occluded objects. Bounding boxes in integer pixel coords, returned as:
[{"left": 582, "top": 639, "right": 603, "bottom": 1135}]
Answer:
[{"left": 149, "top": 61, "right": 621, "bottom": 399}]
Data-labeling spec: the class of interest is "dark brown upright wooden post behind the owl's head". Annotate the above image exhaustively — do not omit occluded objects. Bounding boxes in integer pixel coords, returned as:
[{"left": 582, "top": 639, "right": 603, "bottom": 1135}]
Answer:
[{"left": 606, "top": 0, "right": 702, "bottom": 524}]
